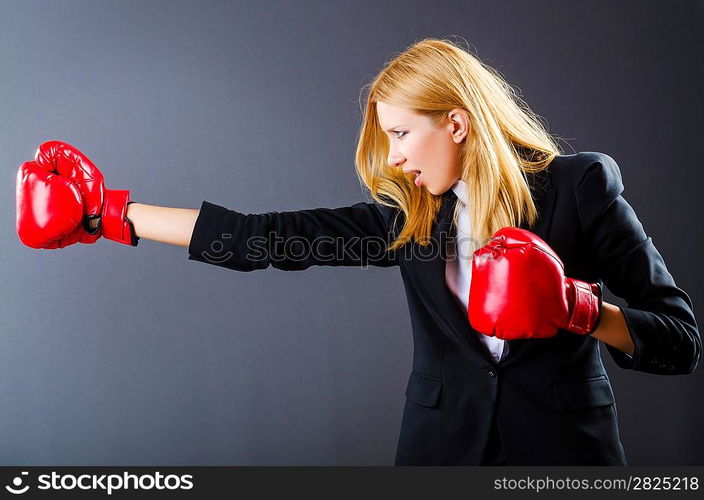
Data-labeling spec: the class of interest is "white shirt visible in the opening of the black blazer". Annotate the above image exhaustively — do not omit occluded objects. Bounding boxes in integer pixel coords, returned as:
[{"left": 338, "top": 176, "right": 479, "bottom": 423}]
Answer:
[{"left": 445, "top": 179, "right": 506, "bottom": 362}]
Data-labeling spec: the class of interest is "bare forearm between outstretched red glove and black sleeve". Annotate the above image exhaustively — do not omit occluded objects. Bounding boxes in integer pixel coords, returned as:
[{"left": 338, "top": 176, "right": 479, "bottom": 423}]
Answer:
[{"left": 127, "top": 203, "right": 198, "bottom": 247}]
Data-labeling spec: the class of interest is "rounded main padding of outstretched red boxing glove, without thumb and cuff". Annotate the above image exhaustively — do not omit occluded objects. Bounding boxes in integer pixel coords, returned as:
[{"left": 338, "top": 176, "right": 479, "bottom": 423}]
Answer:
[{"left": 16, "top": 161, "right": 92, "bottom": 248}]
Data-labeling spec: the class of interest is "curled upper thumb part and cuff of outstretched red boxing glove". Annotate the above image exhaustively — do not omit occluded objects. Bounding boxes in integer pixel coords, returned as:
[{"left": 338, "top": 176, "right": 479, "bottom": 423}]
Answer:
[{"left": 35, "top": 141, "right": 139, "bottom": 246}]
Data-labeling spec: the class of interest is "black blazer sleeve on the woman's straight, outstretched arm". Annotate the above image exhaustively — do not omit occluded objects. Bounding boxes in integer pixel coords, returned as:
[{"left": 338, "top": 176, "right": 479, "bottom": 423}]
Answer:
[{"left": 188, "top": 201, "right": 398, "bottom": 271}]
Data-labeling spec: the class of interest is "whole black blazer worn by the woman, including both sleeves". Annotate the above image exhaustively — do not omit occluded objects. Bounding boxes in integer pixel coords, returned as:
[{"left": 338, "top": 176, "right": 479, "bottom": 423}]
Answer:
[{"left": 188, "top": 152, "right": 702, "bottom": 465}]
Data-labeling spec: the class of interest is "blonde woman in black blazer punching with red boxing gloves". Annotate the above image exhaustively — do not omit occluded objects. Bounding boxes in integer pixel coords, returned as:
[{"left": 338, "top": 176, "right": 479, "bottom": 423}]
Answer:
[{"left": 17, "top": 39, "right": 701, "bottom": 465}]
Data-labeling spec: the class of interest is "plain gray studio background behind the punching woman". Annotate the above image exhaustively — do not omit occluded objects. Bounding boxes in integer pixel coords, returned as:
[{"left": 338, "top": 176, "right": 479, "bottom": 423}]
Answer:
[{"left": 0, "top": 0, "right": 704, "bottom": 465}]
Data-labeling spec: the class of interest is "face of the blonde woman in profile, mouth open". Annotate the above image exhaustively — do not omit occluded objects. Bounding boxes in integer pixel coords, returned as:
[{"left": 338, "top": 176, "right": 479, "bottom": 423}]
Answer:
[{"left": 376, "top": 101, "right": 469, "bottom": 195}]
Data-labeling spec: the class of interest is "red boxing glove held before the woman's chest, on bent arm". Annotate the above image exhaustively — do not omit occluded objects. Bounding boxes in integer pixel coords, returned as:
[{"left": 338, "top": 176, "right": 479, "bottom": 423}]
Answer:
[{"left": 468, "top": 227, "right": 602, "bottom": 340}]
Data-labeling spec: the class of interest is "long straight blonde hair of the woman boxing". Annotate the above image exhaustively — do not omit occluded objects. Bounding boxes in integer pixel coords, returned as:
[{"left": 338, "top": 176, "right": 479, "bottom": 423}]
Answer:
[{"left": 355, "top": 38, "right": 560, "bottom": 251}]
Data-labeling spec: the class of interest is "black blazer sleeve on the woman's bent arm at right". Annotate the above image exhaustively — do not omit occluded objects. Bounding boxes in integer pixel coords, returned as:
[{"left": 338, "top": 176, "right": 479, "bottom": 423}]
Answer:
[{"left": 573, "top": 152, "right": 702, "bottom": 375}]
